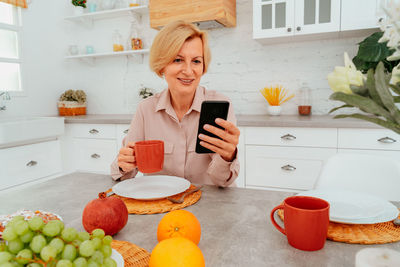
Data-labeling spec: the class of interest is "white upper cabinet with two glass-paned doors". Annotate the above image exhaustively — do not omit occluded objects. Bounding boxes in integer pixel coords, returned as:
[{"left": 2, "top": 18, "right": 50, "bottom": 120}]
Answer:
[{"left": 253, "top": 0, "right": 340, "bottom": 39}]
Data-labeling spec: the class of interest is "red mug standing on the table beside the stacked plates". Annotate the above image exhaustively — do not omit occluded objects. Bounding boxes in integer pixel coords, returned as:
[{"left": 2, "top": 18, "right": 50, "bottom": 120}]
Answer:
[{"left": 270, "top": 196, "right": 329, "bottom": 251}]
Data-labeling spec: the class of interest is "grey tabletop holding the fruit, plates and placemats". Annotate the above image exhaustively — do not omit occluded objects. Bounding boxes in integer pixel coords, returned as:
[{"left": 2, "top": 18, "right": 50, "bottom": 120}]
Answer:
[{"left": 0, "top": 173, "right": 400, "bottom": 267}]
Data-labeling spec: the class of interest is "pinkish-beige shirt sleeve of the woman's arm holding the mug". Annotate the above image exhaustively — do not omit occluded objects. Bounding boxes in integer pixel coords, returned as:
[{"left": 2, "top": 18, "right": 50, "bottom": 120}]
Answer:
[{"left": 111, "top": 104, "right": 144, "bottom": 181}]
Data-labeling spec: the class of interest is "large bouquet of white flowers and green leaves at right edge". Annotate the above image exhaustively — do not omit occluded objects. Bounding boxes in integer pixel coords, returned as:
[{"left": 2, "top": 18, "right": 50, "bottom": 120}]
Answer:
[{"left": 328, "top": 1, "right": 400, "bottom": 134}]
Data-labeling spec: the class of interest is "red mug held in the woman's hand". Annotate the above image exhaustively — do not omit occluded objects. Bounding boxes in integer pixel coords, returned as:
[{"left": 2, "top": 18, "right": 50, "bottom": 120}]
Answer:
[{"left": 135, "top": 140, "right": 164, "bottom": 173}]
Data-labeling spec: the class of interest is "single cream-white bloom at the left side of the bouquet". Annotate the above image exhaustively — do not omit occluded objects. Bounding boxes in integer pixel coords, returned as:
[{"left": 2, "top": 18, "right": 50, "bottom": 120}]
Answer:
[{"left": 328, "top": 53, "right": 364, "bottom": 94}]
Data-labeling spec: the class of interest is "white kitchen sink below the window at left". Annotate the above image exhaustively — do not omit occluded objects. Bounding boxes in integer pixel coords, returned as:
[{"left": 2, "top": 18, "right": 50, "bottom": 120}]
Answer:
[{"left": 0, "top": 117, "right": 64, "bottom": 148}]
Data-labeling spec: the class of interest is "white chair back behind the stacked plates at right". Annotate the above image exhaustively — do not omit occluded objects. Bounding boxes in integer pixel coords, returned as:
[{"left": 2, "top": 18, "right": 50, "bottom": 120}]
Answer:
[{"left": 315, "top": 153, "right": 400, "bottom": 201}]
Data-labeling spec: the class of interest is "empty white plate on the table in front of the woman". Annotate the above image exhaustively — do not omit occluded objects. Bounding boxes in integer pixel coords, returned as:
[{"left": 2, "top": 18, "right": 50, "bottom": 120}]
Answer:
[{"left": 112, "top": 175, "right": 190, "bottom": 200}]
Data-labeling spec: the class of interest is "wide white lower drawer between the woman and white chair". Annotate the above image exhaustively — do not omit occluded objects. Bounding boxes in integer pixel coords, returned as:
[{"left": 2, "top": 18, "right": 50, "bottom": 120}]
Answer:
[{"left": 246, "top": 145, "right": 336, "bottom": 190}]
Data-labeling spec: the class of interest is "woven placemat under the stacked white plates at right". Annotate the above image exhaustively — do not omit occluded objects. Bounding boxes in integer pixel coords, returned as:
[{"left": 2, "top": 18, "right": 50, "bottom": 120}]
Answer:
[{"left": 278, "top": 209, "right": 400, "bottom": 245}]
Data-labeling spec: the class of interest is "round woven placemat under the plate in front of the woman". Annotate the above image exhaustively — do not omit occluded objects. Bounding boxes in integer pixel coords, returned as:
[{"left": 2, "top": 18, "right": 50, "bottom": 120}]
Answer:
[{"left": 109, "top": 185, "right": 201, "bottom": 214}]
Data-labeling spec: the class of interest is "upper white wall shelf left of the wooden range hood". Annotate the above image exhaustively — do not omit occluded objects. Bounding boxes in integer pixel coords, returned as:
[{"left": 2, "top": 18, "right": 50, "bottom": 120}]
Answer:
[{"left": 64, "top": 6, "right": 148, "bottom": 21}]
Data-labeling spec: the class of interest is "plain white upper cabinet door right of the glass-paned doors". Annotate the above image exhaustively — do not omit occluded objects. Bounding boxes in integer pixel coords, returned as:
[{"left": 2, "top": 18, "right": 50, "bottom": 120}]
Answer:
[{"left": 340, "top": 0, "right": 387, "bottom": 31}]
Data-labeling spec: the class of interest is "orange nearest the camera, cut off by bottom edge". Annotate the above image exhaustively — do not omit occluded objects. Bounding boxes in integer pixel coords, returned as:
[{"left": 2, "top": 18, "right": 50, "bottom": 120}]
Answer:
[{"left": 149, "top": 237, "right": 205, "bottom": 267}]
